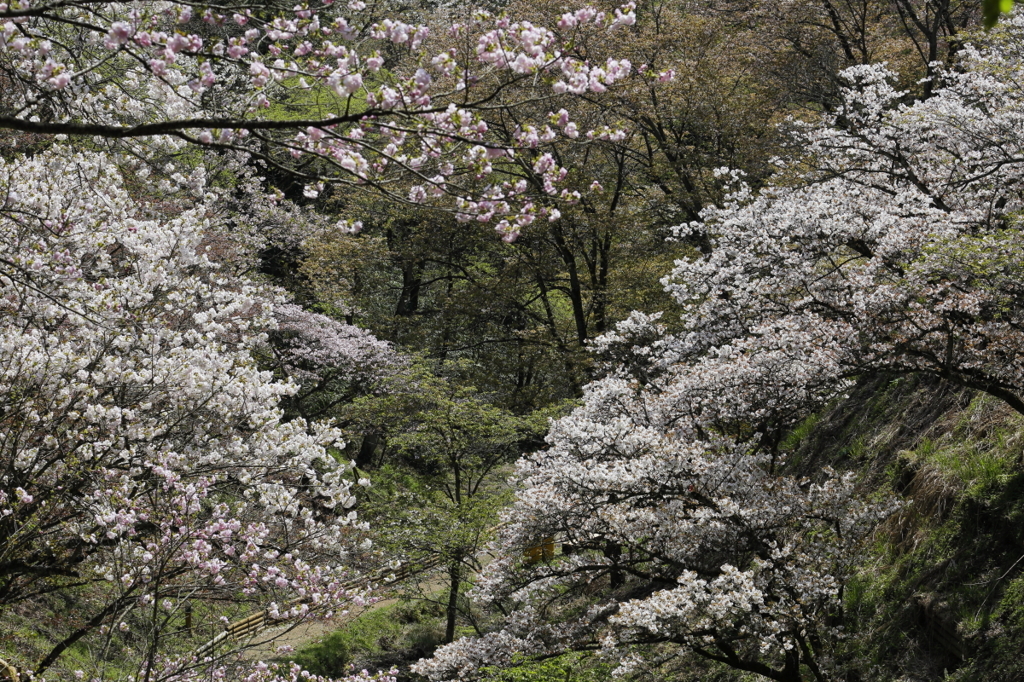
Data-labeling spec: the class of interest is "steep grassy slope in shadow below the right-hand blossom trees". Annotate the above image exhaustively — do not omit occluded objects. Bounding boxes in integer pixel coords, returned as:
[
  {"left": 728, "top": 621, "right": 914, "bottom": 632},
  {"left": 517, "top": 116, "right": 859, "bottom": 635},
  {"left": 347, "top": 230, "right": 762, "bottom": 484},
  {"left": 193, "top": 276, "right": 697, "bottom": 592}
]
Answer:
[{"left": 792, "top": 377, "right": 1024, "bottom": 682}]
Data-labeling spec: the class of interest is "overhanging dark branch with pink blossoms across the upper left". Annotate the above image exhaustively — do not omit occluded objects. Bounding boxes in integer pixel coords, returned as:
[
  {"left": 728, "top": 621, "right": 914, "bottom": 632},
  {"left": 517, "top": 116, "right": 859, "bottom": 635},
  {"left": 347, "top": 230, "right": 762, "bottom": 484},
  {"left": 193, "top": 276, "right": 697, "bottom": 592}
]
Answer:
[{"left": 0, "top": 0, "right": 636, "bottom": 239}]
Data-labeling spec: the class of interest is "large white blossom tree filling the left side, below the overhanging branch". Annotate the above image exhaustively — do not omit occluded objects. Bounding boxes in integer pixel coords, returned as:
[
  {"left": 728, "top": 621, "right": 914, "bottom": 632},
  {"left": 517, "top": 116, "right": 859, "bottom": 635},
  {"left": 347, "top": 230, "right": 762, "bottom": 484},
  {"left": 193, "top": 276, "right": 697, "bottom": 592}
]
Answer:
[{"left": 0, "top": 145, "right": 387, "bottom": 680}]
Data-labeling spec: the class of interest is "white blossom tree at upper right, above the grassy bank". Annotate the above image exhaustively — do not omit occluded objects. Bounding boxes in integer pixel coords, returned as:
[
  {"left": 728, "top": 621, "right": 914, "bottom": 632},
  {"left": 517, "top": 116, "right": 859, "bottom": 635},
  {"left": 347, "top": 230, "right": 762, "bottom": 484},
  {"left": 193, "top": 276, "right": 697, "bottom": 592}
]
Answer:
[{"left": 666, "top": 17, "right": 1024, "bottom": 411}]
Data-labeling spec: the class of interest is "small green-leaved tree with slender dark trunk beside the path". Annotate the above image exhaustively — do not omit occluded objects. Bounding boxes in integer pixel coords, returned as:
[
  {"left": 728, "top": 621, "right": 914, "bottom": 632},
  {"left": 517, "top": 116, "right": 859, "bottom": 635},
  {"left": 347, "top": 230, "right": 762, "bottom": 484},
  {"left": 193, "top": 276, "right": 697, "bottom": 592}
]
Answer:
[{"left": 346, "top": 364, "right": 543, "bottom": 641}]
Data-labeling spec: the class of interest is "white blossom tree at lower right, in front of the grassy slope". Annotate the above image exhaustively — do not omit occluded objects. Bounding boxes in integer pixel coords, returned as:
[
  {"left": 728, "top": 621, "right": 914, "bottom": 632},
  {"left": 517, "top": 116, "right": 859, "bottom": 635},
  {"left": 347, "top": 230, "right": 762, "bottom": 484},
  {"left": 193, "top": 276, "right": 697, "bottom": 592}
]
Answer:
[{"left": 418, "top": 315, "right": 891, "bottom": 682}]
